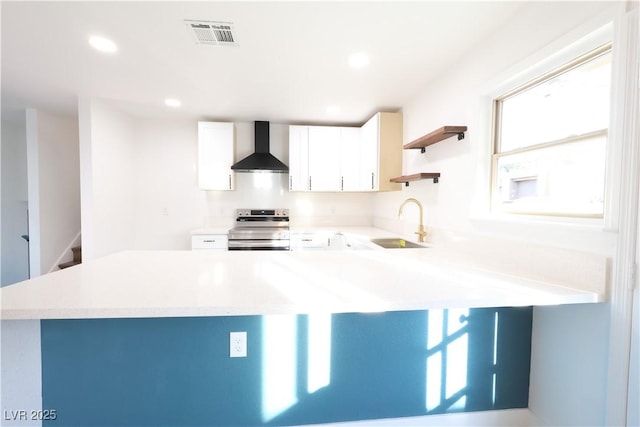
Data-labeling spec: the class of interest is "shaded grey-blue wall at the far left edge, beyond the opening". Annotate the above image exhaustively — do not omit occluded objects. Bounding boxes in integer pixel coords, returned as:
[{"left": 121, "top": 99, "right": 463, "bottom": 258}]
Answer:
[{"left": 1, "top": 117, "right": 29, "bottom": 286}]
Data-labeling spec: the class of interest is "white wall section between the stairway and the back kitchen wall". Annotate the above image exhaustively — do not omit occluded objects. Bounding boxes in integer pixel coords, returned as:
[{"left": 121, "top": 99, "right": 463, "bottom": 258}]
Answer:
[{"left": 78, "top": 99, "right": 137, "bottom": 260}]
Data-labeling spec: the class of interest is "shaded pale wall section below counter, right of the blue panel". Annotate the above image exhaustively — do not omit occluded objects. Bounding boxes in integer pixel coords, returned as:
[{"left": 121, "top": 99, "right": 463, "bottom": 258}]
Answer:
[{"left": 529, "top": 304, "right": 609, "bottom": 426}]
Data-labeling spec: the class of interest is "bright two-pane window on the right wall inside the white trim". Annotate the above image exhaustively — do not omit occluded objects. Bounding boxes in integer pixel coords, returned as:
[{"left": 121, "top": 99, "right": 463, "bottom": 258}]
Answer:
[{"left": 492, "top": 45, "right": 611, "bottom": 218}]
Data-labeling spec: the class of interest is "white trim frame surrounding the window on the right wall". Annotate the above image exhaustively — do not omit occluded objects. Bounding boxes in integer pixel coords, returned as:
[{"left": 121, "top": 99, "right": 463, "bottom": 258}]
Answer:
[{"left": 471, "top": 21, "right": 620, "bottom": 231}]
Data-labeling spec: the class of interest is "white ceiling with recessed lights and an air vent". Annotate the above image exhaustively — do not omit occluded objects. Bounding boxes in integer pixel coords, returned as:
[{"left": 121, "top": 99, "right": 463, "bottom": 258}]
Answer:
[{"left": 1, "top": 1, "right": 524, "bottom": 124}]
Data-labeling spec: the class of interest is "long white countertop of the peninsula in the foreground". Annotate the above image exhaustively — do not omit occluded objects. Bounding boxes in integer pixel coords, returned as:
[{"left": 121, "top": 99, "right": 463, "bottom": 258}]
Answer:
[{"left": 0, "top": 230, "right": 606, "bottom": 319}]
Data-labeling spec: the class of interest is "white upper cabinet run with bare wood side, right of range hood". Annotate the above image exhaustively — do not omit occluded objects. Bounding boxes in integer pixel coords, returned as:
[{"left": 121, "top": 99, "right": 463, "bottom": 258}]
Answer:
[{"left": 289, "top": 113, "right": 402, "bottom": 192}]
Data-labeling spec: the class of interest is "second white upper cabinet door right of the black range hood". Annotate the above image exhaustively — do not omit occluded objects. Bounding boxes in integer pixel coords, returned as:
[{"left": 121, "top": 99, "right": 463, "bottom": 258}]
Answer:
[{"left": 309, "top": 126, "right": 341, "bottom": 191}]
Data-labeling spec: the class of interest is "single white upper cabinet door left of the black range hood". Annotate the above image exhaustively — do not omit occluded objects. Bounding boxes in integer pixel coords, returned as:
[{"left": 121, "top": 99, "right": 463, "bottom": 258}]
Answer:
[{"left": 198, "top": 122, "right": 234, "bottom": 190}]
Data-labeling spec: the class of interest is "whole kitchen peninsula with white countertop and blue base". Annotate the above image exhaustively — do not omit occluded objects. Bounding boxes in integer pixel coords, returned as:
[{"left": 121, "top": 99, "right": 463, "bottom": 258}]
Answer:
[{"left": 0, "top": 228, "right": 607, "bottom": 426}]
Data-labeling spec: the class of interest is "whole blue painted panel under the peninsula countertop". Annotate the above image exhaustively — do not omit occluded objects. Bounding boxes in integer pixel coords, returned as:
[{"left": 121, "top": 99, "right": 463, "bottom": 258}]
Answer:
[{"left": 41, "top": 308, "right": 532, "bottom": 426}]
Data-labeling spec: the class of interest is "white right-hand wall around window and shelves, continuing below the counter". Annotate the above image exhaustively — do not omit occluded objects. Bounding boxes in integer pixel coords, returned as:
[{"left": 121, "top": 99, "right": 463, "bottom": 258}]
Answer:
[{"left": 374, "top": 2, "right": 622, "bottom": 425}]
